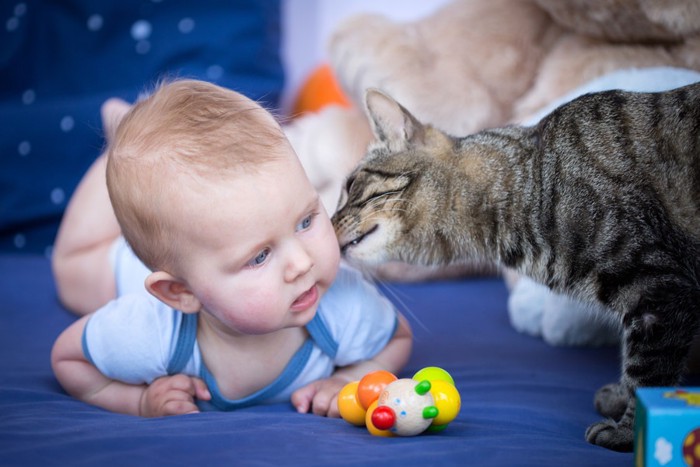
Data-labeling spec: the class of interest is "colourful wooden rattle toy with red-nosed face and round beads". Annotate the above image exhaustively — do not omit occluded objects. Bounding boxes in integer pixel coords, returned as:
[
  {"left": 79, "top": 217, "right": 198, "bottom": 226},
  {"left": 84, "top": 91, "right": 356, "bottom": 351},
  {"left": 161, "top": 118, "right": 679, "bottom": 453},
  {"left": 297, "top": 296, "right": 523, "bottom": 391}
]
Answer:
[{"left": 338, "top": 366, "right": 462, "bottom": 436}]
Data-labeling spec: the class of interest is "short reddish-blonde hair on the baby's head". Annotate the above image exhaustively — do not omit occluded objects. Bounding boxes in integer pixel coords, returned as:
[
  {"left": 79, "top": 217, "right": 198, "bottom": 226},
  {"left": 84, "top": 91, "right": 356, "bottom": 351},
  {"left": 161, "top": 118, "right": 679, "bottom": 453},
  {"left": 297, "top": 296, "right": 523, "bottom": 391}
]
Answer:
[{"left": 107, "top": 80, "right": 287, "bottom": 272}]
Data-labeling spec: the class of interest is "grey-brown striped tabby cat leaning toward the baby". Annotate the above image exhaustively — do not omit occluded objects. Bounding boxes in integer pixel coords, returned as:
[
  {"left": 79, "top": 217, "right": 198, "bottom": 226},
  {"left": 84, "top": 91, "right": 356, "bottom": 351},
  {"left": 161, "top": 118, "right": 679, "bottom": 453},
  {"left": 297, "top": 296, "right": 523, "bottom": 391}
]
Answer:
[{"left": 333, "top": 83, "right": 700, "bottom": 451}]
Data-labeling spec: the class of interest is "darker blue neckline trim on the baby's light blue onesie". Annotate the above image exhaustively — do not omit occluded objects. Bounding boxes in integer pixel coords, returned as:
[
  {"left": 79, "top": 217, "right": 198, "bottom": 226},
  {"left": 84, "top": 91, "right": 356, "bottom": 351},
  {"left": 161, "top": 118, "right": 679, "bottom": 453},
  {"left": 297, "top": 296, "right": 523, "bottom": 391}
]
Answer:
[{"left": 168, "top": 310, "right": 338, "bottom": 411}]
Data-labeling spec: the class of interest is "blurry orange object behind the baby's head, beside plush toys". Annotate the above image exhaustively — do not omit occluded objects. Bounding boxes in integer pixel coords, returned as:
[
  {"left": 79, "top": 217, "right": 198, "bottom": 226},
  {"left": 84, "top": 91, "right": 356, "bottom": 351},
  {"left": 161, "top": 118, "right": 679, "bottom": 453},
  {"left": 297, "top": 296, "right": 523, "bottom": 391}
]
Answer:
[{"left": 292, "top": 63, "right": 352, "bottom": 117}]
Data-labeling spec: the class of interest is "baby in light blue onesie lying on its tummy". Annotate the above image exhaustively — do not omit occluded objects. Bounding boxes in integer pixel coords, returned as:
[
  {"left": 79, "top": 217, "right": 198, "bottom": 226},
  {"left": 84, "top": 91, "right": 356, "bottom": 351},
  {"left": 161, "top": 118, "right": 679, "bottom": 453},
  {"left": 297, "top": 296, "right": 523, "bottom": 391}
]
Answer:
[{"left": 51, "top": 80, "right": 412, "bottom": 416}]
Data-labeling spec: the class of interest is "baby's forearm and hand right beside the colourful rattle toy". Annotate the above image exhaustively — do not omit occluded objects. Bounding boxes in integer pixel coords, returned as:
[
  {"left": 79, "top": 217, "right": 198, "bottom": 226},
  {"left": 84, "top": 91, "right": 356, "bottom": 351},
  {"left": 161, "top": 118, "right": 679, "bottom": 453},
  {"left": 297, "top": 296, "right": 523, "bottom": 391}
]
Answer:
[{"left": 292, "top": 313, "right": 413, "bottom": 417}]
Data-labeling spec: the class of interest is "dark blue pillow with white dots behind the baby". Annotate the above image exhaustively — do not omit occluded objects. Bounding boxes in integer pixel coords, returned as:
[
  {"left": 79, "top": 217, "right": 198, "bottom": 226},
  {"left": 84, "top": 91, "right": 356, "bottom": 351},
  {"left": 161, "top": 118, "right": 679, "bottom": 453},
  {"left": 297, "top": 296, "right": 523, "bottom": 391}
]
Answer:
[{"left": 0, "top": 0, "right": 284, "bottom": 254}]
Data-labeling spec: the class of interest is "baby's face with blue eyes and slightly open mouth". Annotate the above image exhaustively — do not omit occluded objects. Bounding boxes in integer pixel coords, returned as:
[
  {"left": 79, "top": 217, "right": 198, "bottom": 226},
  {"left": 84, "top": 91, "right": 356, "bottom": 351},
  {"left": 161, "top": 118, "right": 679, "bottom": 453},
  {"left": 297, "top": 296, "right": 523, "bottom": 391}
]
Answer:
[{"left": 175, "top": 149, "right": 340, "bottom": 334}]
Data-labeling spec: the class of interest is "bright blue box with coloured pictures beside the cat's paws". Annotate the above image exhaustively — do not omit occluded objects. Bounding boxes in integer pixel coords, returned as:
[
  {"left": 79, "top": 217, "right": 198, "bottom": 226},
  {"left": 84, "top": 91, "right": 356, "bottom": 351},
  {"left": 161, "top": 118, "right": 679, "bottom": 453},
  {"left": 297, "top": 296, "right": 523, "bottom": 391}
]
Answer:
[{"left": 634, "top": 387, "right": 700, "bottom": 467}]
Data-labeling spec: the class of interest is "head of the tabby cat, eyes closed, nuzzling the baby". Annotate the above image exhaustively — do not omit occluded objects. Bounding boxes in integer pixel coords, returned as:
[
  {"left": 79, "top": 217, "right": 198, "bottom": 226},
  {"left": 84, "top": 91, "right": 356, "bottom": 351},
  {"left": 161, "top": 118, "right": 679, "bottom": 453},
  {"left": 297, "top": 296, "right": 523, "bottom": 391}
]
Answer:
[{"left": 332, "top": 90, "right": 452, "bottom": 264}]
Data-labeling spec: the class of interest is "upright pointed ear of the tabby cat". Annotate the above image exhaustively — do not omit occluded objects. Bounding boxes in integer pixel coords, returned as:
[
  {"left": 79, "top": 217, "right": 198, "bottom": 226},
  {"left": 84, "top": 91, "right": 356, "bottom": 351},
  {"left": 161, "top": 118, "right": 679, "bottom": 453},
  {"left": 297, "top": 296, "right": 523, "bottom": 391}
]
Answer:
[{"left": 365, "top": 88, "right": 425, "bottom": 151}]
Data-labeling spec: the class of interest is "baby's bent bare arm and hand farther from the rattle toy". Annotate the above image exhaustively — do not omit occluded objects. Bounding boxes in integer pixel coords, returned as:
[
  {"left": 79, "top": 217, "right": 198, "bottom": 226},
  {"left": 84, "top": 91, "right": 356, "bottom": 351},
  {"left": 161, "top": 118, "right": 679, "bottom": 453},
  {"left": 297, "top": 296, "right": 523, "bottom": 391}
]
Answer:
[{"left": 51, "top": 316, "right": 211, "bottom": 417}]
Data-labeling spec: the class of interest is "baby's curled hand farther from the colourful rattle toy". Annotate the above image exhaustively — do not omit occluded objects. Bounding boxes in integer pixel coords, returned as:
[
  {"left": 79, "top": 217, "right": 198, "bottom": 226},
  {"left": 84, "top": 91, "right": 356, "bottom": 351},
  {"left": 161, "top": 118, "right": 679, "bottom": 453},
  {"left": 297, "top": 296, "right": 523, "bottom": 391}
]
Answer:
[{"left": 139, "top": 374, "right": 211, "bottom": 417}]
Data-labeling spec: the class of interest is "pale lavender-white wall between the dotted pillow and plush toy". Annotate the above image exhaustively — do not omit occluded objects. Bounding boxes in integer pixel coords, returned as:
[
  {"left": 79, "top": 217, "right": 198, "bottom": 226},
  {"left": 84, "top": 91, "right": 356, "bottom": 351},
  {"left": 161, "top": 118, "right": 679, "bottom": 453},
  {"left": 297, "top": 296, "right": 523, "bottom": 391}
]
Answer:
[{"left": 282, "top": 0, "right": 448, "bottom": 110}]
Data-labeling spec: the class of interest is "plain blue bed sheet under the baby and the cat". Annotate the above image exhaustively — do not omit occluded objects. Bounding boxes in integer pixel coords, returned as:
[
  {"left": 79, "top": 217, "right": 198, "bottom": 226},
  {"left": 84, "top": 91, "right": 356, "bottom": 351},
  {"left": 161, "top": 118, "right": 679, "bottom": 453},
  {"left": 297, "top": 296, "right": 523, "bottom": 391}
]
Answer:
[{"left": 0, "top": 254, "right": 633, "bottom": 466}]
